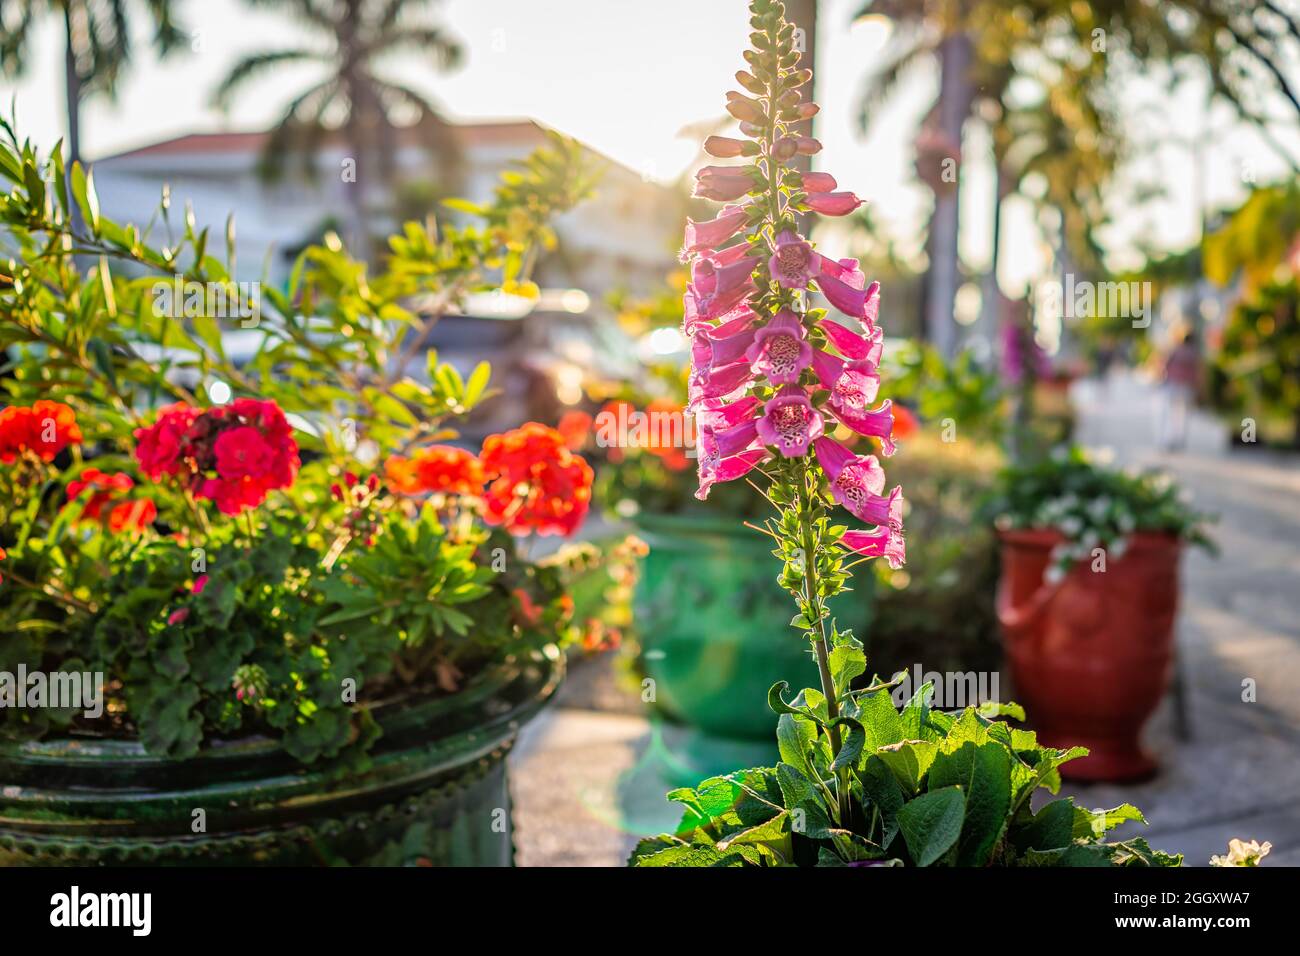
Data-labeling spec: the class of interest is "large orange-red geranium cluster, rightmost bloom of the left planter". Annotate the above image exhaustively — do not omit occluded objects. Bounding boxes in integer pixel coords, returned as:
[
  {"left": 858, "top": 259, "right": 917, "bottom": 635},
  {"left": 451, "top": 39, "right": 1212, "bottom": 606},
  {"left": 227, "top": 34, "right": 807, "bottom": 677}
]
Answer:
[{"left": 478, "top": 421, "right": 593, "bottom": 535}]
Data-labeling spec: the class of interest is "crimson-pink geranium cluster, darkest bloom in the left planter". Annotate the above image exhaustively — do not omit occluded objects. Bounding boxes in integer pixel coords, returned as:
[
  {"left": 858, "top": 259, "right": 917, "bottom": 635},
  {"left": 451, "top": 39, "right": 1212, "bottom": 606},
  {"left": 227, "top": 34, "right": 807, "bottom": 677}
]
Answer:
[{"left": 135, "top": 398, "right": 300, "bottom": 515}]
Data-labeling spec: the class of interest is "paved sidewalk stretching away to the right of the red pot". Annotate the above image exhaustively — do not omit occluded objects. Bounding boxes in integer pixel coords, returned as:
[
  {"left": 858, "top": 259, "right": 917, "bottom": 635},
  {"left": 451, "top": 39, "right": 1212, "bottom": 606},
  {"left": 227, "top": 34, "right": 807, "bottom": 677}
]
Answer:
[{"left": 1070, "top": 377, "right": 1300, "bottom": 866}]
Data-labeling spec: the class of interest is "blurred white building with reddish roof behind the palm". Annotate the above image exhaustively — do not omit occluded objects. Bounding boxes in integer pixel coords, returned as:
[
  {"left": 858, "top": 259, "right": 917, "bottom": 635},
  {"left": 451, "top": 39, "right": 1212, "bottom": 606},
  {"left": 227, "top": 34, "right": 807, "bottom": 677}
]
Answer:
[{"left": 94, "top": 120, "right": 683, "bottom": 303}]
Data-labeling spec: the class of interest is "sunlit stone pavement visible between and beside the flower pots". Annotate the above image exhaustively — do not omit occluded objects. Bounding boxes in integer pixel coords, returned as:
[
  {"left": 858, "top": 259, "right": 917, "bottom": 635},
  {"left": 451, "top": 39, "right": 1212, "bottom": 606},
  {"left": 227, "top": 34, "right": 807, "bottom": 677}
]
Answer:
[{"left": 511, "top": 377, "right": 1300, "bottom": 866}]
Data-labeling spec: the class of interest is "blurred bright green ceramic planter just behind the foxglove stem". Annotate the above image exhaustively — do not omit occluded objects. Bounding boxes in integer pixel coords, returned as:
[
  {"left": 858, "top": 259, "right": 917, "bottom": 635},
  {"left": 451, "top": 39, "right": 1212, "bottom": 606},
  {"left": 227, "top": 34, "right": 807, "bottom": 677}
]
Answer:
[{"left": 636, "top": 515, "right": 871, "bottom": 741}]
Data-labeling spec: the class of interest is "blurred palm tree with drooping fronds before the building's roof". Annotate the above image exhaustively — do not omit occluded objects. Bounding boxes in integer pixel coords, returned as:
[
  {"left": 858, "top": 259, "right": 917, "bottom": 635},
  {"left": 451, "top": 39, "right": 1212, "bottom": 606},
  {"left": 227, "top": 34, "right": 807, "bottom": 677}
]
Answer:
[{"left": 213, "top": 0, "right": 462, "bottom": 250}]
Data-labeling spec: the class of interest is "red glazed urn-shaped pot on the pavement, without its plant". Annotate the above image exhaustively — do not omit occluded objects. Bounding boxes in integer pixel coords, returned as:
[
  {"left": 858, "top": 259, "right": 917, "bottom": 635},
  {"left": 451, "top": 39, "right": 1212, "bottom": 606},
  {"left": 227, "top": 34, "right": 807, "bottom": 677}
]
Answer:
[{"left": 997, "top": 531, "right": 1182, "bottom": 780}]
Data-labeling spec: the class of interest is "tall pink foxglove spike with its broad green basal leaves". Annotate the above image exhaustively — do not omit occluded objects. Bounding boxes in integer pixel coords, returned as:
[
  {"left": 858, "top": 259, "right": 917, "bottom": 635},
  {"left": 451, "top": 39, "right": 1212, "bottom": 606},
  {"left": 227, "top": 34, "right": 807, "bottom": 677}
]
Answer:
[{"left": 632, "top": 0, "right": 1179, "bottom": 866}]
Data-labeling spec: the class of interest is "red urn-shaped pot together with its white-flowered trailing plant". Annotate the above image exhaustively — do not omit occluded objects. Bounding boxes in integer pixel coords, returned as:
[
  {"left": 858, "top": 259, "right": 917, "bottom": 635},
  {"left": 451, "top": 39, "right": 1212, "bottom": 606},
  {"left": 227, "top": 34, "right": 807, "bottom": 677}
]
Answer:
[{"left": 991, "top": 449, "right": 1210, "bottom": 780}]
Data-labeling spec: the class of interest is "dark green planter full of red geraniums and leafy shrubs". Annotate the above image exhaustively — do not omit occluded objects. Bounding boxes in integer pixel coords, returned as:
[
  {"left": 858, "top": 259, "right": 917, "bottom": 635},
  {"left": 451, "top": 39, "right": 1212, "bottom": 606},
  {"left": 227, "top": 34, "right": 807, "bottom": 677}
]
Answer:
[{"left": 0, "top": 126, "right": 618, "bottom": 865}]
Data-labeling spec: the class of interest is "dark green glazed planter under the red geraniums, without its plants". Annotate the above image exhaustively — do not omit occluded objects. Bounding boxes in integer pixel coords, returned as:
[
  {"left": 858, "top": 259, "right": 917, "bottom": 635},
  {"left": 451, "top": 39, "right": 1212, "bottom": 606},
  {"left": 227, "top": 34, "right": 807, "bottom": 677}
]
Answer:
[{"left": 0, "top": 649, "right": 564, "bottom": 866}]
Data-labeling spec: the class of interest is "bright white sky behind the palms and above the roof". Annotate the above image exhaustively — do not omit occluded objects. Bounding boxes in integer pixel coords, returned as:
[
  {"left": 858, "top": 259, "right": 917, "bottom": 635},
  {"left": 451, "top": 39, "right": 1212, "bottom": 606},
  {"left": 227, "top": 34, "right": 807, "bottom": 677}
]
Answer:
[{"left": 0, "top": 0, "right": 1300, "bottom": 294}]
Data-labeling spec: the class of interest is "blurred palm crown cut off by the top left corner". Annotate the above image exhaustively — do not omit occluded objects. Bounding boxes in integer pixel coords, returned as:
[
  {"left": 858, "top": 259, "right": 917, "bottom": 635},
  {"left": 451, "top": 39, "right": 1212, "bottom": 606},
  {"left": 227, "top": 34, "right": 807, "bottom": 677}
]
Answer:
[{"left": 0, "top": 0, "right": 186, "bottom": 166}]
